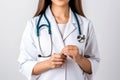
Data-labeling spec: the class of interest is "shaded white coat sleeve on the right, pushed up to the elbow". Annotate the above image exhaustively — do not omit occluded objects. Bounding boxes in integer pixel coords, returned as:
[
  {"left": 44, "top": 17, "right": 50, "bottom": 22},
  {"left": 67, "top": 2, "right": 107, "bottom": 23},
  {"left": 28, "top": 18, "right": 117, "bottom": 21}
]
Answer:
[{"left": 85, "top": 21, "right": 100, "bottom": 80}]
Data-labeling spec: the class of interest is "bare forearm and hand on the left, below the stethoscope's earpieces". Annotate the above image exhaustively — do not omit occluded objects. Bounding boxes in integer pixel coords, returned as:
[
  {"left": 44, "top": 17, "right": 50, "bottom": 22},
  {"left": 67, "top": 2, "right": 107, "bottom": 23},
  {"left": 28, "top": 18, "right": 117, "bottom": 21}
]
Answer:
[{"left": 32, "top": 54, "right": 66, "bottom": 75}]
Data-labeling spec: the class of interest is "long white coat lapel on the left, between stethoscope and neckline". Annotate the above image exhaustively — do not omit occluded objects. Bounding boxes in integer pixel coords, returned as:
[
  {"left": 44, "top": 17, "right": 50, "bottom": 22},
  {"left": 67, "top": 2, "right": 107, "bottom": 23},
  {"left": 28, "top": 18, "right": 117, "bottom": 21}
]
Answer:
[{"left": 46, "top": 6, "right": 64, "bottom": 53}]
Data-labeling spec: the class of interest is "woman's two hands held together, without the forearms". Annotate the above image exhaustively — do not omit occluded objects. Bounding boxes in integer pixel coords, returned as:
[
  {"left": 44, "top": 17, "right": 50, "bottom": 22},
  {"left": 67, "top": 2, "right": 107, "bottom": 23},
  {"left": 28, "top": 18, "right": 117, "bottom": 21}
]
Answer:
[{"left": 49, "top": 45, "right": 80, "bottom": 68}]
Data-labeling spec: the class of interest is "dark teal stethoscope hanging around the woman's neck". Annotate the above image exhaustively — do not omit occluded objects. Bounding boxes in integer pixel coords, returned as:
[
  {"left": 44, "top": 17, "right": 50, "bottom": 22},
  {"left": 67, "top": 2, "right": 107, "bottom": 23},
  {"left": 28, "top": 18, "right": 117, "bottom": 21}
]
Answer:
[{"left": 36, "top": 13, "right": 85, "bottom": 58}]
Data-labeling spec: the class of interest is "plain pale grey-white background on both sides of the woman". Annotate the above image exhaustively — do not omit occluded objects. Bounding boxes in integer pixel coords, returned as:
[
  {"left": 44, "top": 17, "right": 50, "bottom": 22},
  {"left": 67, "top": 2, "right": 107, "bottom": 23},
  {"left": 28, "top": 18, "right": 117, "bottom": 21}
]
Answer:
[{"left": 0, "top": 0, "right": 120, "bottom": 80}]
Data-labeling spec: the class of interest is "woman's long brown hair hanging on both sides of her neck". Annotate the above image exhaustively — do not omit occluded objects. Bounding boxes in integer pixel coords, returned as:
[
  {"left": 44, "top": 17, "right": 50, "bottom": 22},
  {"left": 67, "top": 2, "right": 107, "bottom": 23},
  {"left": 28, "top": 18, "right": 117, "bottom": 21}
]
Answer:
[{"left": 34, "top": 0, "right": 85, "bottom": 17}]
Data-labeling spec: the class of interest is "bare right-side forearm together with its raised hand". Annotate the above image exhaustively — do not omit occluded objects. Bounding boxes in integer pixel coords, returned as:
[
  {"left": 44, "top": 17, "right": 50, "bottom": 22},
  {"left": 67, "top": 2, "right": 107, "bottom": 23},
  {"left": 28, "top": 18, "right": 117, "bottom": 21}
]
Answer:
[{"left": 61, "top": 45, "right": 92, "bottom": 74}]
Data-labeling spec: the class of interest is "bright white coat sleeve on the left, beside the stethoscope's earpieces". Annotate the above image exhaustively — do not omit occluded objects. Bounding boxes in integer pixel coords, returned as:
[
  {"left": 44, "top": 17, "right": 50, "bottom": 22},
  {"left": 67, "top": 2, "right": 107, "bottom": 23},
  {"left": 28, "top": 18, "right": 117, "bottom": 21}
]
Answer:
[{"left": 18, "top": 20, "right": 37, "bottom": 80}]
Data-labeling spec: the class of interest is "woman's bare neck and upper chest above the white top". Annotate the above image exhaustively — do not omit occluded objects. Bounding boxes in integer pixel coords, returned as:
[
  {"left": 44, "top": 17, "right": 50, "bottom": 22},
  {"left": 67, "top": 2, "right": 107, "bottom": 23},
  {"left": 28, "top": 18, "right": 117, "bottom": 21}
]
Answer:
[{"left": 51, "top": 5, "right": 69, "bottom": 23}]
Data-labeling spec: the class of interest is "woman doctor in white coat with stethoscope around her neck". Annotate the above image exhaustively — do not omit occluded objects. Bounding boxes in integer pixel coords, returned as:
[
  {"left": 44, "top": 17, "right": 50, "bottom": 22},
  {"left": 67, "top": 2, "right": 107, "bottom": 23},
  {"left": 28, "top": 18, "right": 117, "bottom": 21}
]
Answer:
[{"left": 18, "top": 0, "right": 100, "bottom": 80}]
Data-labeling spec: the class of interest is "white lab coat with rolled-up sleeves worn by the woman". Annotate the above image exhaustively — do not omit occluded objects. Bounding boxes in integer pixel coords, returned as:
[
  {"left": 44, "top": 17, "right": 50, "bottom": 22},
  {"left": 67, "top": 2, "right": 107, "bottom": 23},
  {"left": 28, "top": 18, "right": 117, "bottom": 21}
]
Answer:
[{"left": 18, "top": 7, "right": 100, "bottom": 80}]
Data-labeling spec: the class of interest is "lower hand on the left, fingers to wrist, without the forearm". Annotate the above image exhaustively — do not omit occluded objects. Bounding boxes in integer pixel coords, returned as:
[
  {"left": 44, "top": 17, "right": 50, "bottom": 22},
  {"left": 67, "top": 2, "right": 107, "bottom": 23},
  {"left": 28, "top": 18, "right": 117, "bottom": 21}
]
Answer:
[{"left": 48, "top": 54, "right": 66, "bottom": 69}]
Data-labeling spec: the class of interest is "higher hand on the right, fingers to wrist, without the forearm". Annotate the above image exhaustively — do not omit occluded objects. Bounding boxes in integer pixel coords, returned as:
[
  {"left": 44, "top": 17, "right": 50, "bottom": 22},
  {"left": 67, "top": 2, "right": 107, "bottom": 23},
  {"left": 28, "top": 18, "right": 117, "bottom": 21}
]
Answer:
[{"left": 61, "top": 45, "right": 80, "bottom": 62}]
